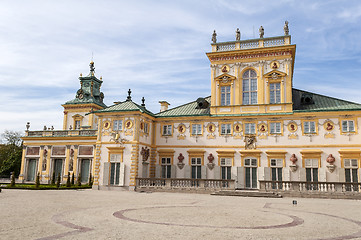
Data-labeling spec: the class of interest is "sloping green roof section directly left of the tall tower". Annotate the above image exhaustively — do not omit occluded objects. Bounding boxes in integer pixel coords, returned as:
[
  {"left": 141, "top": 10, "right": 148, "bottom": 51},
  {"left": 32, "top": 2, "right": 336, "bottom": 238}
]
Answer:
[{"left": 155, "top": 97, "right": 211, "bottom": 117}]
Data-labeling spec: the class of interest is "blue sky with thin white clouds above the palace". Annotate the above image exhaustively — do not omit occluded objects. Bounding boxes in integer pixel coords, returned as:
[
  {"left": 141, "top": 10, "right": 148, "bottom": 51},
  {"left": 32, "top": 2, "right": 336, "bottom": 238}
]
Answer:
[{"left": 0, "top": 0, "right": 361, "bottom": 133}]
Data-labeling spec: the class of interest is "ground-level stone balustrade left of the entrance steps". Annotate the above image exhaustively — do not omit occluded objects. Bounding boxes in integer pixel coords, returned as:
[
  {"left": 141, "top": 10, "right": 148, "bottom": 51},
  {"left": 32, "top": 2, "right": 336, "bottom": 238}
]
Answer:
[{"left": 136, "top": 178, "right": 235, "bottom": 189}]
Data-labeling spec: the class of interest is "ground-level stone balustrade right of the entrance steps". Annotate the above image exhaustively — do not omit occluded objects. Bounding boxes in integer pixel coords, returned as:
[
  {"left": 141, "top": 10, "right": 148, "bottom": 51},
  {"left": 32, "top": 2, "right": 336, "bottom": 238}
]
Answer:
[{"left": 259, "top": 180, "right": 361, "bottom": 192}]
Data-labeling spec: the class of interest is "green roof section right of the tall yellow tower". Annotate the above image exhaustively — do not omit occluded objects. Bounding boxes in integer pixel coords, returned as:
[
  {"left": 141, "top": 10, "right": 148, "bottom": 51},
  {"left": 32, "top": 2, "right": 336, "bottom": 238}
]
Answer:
[{"left": 292, "top": 89, "right": 361, "bottom": 112}]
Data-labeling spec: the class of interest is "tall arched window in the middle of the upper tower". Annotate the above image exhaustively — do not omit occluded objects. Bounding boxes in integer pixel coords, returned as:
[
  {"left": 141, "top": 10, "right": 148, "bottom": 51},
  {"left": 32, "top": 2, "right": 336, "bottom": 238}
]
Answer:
[{"left": 242, "top": 70, "right": 257, "bottom": 105}]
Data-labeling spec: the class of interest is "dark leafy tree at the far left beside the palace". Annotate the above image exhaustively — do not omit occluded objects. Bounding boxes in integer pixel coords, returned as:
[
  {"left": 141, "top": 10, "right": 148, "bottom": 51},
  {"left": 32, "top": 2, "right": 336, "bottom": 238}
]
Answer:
[{"left": 0, "top": 130, "right": 22, "bottom": 176}]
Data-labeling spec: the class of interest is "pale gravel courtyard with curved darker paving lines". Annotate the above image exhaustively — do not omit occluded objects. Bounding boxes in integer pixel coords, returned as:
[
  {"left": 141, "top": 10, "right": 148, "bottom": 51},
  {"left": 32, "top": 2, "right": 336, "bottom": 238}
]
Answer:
[{"left": 0, "top": 190, "right": 361, "bottom": 240}]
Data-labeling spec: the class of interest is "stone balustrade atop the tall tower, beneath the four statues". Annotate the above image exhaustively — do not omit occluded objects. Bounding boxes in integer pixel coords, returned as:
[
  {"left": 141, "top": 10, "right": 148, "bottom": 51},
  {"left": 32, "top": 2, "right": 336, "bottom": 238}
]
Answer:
[{"left": 212, "top": 35, "right": 291, "bottom": 52}]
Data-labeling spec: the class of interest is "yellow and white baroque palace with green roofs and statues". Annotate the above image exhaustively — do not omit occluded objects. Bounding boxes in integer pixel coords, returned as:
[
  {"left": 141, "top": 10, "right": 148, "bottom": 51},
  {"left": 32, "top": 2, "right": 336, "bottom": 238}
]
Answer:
[{"left": 19, "top": 23, "right": 361, "bottom": 191}]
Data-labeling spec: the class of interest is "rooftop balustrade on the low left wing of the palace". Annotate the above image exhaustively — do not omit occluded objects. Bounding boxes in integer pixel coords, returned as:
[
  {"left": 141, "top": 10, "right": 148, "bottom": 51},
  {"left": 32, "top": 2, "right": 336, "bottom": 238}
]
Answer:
[{"left": 25, "top": 130, "right": 97, "bottom": 137}]
